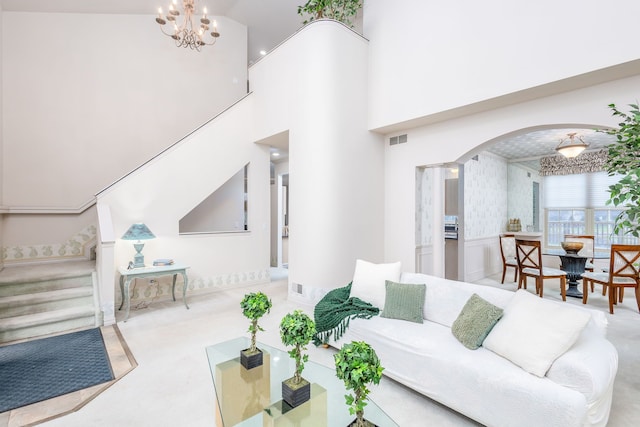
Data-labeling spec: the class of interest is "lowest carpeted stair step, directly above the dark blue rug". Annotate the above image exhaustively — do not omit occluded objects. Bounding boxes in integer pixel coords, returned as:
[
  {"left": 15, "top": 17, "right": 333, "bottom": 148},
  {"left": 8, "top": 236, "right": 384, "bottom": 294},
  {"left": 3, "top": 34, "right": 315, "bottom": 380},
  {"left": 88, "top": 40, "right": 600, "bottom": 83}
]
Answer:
[{"left": 0, "top": 305, "right": 96, "bottom": 343}]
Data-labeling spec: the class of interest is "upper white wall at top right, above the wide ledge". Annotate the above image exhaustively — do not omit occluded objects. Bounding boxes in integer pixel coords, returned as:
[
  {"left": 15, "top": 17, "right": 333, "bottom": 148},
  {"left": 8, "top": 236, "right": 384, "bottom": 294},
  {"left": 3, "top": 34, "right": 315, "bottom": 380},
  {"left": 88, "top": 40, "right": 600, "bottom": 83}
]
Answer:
[{"left": 364, "top": 0, "right": 640, "bottom": 129}]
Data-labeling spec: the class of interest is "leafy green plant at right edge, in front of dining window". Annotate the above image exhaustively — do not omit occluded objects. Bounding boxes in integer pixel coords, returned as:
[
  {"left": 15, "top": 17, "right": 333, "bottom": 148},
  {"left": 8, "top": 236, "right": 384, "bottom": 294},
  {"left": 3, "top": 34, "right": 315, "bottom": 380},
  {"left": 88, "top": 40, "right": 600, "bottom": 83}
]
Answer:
[{"left": 600, "top": 104, "right": 640, "bottom": 237}]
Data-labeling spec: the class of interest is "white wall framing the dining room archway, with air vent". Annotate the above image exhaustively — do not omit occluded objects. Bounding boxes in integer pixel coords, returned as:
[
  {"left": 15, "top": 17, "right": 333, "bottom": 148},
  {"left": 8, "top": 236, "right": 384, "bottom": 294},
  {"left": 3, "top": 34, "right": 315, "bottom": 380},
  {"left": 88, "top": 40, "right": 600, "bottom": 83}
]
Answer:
[{"left": 385, "top": 76, "right": 640, "bottom": 276}]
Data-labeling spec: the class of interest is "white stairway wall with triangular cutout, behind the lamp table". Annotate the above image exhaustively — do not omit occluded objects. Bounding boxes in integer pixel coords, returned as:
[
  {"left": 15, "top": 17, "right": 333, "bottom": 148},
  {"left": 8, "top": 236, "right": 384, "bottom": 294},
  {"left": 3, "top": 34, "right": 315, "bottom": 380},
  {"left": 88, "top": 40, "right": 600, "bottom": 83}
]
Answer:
[{"left": 97, "top": 96, "right": 269, "bottom": 321}]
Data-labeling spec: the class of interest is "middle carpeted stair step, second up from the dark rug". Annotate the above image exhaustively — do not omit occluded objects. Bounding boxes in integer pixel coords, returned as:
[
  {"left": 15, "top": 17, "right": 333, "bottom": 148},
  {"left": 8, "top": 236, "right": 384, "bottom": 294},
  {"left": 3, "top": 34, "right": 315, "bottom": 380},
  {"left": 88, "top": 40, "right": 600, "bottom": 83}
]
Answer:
[{"left": 0, "top": 286, "right": 93, "bottom": 318}]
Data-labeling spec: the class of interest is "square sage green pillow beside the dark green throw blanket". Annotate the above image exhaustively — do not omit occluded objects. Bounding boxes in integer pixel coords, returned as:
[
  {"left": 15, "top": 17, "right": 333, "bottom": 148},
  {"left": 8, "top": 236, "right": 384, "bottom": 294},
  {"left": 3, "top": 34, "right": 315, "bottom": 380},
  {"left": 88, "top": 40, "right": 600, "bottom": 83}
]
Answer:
[{"left": 380, "top": 280, "right": 427, "bottom": 323}]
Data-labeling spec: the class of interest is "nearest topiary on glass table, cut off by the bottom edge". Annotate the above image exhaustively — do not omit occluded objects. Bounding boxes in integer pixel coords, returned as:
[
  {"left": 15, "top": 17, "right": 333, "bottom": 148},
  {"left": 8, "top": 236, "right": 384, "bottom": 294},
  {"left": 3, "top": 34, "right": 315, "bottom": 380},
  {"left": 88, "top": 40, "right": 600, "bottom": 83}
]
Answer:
[{"left": 333, "top": 341, "right": 384, "bottom": 427}]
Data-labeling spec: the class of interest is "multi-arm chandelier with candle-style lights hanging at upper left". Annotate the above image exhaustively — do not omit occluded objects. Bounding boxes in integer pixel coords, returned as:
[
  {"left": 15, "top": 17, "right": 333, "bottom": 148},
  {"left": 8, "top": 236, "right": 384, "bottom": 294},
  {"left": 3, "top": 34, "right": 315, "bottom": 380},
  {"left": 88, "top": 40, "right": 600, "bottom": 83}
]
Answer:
[{"left": 156, "top": 0, "right": 220, "bottom": 52}]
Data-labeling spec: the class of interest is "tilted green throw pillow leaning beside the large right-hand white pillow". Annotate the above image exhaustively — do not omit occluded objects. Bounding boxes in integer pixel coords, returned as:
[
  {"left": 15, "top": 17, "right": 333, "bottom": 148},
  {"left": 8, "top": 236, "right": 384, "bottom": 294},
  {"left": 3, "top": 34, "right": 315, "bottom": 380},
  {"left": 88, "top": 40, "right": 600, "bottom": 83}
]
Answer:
[{"left": 451, "top": 294, "right": 503, "bottom": 350}]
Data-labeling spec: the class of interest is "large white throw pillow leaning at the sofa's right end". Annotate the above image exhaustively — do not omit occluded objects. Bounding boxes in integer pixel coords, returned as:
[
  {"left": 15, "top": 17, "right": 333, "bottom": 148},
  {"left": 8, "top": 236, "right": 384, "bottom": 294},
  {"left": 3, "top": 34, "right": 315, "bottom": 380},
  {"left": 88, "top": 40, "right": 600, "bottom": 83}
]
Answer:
[{"left": 482, "top": 289, "right": 591, "bottom": 377}]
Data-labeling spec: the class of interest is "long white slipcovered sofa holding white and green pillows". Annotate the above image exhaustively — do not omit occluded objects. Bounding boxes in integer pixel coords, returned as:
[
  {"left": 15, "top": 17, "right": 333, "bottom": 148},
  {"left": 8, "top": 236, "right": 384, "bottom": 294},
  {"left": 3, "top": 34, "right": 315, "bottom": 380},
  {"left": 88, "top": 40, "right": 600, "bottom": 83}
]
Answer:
[{"left": 329, "top": 273, "right": 618, "bottom": 427}]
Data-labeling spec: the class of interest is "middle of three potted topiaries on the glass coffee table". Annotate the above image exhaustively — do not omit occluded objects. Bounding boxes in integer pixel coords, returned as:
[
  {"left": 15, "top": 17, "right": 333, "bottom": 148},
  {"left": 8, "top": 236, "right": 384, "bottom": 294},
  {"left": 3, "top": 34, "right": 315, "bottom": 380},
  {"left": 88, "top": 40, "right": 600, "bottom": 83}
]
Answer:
[{"left": 280, "top": 310, "right": 316, "bottom": 408}]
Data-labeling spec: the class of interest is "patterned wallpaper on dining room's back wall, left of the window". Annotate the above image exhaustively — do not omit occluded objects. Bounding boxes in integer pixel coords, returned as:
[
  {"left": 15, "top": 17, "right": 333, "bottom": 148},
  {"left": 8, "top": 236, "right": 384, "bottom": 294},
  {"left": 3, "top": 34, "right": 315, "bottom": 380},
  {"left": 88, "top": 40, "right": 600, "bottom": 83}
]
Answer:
[{"left": 505, "top": 164, "right": 542, "bottom": 231}]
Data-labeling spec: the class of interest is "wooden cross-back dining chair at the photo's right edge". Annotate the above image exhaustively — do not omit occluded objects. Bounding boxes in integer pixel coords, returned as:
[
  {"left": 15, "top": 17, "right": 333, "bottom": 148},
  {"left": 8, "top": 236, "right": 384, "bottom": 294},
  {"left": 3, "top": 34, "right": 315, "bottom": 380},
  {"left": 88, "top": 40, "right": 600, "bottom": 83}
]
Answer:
[{"left": 582, "top": 245, "right": 640, "bottom": 314}]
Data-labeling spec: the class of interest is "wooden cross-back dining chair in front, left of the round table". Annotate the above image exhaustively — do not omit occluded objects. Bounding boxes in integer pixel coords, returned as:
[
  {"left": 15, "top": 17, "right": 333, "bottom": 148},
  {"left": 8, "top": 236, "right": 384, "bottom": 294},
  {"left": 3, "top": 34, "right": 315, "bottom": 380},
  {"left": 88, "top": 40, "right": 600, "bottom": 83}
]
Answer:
[{"left": 516, "top": 239, "right": 567, "bottom": 301}]
